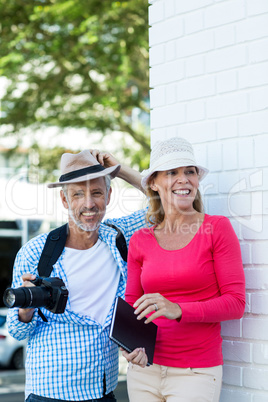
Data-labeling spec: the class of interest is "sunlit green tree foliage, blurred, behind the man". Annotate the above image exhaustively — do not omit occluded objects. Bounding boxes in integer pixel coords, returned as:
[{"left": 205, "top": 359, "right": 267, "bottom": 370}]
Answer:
[{"left": 0, "top": 0, "right": 150, "bottom": 177}]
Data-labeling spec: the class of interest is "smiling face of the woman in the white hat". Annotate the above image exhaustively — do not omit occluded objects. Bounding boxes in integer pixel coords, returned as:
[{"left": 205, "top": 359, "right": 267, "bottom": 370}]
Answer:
[{"left": 150, "top": 166, "right": 199, "bottom": 215}]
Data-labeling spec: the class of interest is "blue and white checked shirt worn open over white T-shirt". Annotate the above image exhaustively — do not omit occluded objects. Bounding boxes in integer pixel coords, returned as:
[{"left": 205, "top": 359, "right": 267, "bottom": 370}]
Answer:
[{"left": 7, "top": 210, "right": 145, "bottom": 401}]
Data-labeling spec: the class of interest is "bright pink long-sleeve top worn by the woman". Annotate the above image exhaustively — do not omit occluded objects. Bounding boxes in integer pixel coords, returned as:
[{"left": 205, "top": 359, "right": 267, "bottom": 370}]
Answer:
[{"left": 126, "top": 215, "right": 245, "bottom": 367}]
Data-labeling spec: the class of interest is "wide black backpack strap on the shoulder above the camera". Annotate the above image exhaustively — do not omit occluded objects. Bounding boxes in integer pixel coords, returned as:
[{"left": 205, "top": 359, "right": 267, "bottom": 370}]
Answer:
[{"left": 37, "top": 223, "right": 68, "bottom": 277}]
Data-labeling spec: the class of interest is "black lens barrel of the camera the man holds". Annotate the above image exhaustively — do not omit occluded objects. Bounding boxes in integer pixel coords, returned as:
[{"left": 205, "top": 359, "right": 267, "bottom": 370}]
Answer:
[{"left": 3, "top": 286, "right": 50, "bottom": 308}]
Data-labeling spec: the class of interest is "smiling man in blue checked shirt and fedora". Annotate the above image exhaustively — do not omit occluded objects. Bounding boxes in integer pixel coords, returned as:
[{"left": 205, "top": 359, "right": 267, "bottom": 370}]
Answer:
[{"left": 7, "top": 150, "right": 145, "bottom": 402}]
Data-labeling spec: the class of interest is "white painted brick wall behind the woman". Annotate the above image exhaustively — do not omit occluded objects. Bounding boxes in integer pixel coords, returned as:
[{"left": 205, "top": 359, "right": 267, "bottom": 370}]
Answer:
[{"left": 149, "top": 0, "right": 268, "bottom": 402}]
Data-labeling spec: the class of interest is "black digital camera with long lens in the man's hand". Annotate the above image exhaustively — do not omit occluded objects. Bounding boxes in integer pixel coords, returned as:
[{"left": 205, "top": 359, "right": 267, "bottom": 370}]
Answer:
[{"left": 3, "top": 277, "right": 69, "bottom": 314}]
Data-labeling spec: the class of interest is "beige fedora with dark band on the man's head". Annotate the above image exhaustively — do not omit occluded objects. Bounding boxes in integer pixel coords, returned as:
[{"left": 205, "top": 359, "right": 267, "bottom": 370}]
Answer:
[{"left": 48, "top": 150, "right": 121, "bottom": 188}]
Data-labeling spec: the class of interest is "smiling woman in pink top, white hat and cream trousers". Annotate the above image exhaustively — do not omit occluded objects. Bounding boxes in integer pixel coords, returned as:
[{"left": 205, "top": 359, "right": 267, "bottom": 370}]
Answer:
[{"left": 123, "top": 138, "right": 245, "bottom": 402}]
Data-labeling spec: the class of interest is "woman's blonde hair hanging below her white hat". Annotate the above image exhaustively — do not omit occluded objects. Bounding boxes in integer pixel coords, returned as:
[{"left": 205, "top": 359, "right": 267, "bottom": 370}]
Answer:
[{"left": 146, "top": 172, "right": 204, "bottom": 225}]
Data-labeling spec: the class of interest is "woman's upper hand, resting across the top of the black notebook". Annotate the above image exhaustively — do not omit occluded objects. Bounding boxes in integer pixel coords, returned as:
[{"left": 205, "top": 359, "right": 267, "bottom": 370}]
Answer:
[{"left": 133, "top": 293, "right": 182, "bottom": 324}]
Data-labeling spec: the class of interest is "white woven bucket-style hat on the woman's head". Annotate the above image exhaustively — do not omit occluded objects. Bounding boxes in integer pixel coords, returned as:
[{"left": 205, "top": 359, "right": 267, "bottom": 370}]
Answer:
[{"left": 141, "top": 137, "right": 208, "bottom": 188}]
